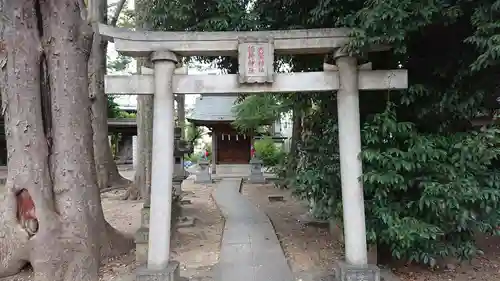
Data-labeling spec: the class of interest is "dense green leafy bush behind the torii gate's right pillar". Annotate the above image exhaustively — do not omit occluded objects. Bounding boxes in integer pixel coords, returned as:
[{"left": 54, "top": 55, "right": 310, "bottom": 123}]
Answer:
[{"left": 294, "top": 101, "right": 500, "bottom": 265}]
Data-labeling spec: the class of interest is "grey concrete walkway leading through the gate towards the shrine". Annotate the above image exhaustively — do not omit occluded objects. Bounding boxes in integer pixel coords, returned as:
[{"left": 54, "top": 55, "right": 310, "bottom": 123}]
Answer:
[{"left": 213, "top": 178, "right": 294, "bottom": 281}]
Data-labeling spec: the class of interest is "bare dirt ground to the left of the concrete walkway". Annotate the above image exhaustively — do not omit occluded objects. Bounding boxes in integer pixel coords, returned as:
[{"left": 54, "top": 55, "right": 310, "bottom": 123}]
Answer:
[{"left": 0, "top": 180, "right": 224, "bottom": 281}]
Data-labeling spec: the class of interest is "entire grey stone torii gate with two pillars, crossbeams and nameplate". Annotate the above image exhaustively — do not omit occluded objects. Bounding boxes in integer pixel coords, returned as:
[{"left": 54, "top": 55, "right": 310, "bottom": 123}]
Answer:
[{"left": 99, "top": 24, "right": 408, "bottom": 280}]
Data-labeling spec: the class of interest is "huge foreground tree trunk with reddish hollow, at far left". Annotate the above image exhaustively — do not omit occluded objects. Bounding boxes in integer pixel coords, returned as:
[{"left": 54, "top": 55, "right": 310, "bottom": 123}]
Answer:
[{"left": 0, "top": 0, "right": 132, "bottom": 281}]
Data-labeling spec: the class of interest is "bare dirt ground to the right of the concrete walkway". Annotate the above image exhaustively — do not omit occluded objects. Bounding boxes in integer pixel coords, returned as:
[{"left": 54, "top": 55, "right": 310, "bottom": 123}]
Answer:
[{"left": 243, "top": 184, "right": 500, "bottom": 281}]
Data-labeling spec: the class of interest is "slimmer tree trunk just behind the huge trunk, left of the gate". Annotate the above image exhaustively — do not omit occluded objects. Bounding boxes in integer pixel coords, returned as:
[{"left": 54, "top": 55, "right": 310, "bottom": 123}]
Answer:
[{"left": 89, "top": 0, "right": 131, "bottom": 189}]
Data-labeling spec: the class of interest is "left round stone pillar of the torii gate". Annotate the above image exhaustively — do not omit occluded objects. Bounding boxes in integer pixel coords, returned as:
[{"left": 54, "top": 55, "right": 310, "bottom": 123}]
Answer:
[{"left": 143, "top": 51, "right": 178, "bottom": 274}]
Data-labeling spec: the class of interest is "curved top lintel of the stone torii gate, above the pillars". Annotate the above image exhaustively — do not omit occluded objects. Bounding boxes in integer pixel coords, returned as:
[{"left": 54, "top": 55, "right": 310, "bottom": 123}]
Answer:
[{"left": 95, "top": 24, "right": 389, "bottom": 57}]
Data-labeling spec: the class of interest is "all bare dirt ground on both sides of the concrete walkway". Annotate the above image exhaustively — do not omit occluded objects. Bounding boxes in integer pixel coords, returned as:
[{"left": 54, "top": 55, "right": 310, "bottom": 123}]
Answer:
[{"left": 5, "top": 177, "right": 500, "bottom": 281}]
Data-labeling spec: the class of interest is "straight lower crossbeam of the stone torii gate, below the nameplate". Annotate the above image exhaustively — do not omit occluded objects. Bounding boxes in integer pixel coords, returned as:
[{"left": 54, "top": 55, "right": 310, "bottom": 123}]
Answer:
[{"left": 105, "top": 69, "right": 408, "bottom": 95}]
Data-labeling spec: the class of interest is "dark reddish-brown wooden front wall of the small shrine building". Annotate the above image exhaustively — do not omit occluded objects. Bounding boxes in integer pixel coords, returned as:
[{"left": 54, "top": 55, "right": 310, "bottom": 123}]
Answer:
[{"left": 212, "top": 123, "right": 252, "bottom": 164}]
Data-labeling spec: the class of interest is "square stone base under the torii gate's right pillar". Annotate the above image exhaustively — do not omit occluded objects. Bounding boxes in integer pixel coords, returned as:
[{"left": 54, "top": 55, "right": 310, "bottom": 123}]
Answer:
[{"left": 335, "top": 262, "right": 380, "bottom": 281}]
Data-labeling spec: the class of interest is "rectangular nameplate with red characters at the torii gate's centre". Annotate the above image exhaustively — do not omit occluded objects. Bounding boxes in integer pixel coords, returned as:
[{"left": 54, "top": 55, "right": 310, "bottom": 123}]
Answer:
[{"left": 238, "top": 38, "right": 274, "bottom": 84}]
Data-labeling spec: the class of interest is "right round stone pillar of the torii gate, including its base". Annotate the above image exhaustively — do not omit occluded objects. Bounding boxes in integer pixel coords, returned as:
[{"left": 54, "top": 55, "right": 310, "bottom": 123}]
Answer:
[{"left": 335, "top": 50, "right": 380, "bottom": 280}]
